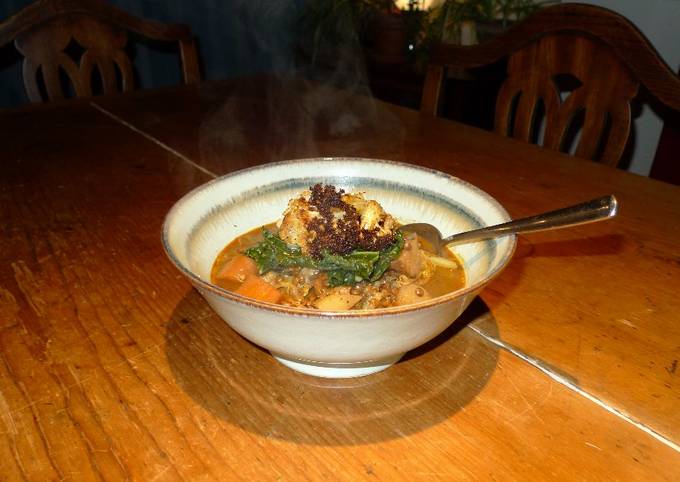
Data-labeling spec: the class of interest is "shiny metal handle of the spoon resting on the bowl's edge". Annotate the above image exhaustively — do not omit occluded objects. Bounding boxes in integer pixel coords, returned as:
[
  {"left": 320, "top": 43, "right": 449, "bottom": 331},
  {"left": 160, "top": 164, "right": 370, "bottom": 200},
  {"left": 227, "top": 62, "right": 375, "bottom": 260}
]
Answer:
[{"left": 442, "top": 195, "right": 618, "bottom": 246}]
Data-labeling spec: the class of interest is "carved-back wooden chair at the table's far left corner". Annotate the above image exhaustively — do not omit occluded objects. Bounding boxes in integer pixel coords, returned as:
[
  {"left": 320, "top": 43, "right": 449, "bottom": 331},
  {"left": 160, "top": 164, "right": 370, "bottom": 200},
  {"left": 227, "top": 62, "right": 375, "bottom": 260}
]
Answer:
[{"left": 0, "top": 0, "right": 201, "bottom": 102}]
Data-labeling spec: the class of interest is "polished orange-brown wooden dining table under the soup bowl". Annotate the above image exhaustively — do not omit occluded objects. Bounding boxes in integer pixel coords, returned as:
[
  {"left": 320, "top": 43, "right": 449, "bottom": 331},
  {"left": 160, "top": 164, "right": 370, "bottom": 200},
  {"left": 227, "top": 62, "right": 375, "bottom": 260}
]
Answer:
[{"left": 0, "top": 79, "right": 680, "bottom": 481}]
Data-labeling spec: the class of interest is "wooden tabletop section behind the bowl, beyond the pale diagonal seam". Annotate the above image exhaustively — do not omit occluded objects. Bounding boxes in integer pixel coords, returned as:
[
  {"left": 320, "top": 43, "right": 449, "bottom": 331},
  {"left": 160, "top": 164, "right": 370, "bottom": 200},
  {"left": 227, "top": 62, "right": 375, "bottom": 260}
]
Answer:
[{"left": 93, "top": 79, "right": 680, "bottom": 441}]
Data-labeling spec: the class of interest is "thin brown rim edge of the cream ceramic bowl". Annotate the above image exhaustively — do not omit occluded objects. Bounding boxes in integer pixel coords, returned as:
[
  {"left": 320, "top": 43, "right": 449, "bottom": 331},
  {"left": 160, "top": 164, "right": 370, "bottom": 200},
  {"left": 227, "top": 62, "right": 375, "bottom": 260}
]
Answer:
[{"left": 161, "top": 156, "right": 517, "bottom": 319}]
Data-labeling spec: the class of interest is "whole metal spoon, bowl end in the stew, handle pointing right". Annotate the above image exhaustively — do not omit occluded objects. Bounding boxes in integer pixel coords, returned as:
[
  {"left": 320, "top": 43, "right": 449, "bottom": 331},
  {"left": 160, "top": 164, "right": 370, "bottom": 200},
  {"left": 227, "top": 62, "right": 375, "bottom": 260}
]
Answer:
[{"left": 399, "top": 195, "right": 618, "bottom": 254}]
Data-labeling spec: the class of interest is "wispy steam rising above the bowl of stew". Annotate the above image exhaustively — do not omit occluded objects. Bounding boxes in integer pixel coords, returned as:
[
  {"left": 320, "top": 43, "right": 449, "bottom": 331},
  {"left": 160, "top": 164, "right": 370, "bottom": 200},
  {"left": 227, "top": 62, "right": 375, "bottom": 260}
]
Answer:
[{"left": 200, "top": 0, "right": 403, "bottom": 172}]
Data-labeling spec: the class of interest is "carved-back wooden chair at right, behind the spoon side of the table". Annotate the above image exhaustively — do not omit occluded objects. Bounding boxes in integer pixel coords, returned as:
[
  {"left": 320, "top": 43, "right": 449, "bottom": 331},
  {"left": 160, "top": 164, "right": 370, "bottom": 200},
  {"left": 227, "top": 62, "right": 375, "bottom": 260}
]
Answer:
[{"left": 421, "top": 4, "right": 680, "bottom": 166}]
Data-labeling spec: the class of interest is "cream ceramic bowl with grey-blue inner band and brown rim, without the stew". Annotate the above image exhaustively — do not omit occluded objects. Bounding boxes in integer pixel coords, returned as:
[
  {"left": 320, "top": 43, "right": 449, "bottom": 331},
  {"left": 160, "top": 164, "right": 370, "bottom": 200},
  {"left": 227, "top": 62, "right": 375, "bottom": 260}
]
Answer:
[{"left": 162, "top": 158, "right": 516, "bottom": 378}]
